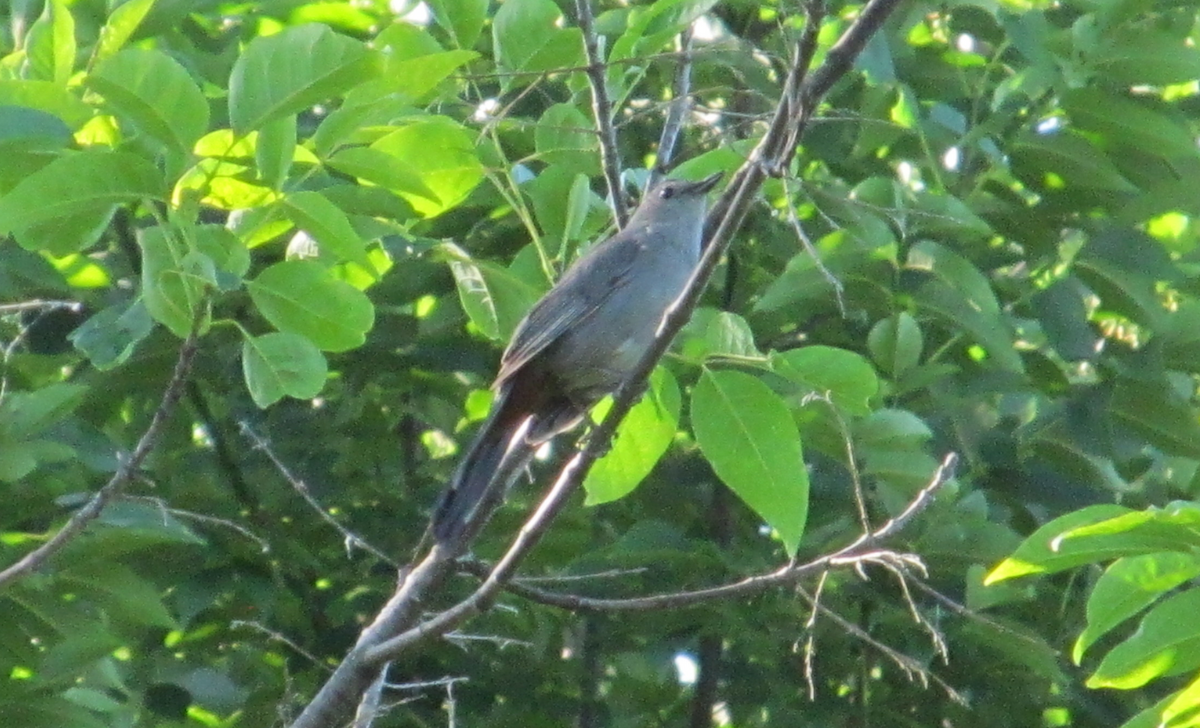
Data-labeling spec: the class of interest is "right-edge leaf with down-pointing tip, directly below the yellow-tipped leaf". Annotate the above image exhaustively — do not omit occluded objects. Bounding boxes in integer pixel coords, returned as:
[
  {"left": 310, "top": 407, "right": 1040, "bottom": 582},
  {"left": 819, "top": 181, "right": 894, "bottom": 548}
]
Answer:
[{"left": 1072, "top": 552, "right": 1200, "bottom": 664}]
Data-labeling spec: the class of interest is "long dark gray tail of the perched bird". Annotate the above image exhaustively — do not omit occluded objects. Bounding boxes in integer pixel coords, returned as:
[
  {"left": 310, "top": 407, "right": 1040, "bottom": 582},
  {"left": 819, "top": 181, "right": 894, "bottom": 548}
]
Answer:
[{"left": 433, "top": 387, "right": 536, "bottom": 545}]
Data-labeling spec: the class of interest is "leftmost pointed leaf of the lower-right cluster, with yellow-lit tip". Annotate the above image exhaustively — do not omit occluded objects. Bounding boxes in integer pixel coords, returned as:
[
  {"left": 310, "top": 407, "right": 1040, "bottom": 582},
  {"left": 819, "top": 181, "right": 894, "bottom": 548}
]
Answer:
[{"left": 984, "top": 504, "right": 1137, "bottom": 584}]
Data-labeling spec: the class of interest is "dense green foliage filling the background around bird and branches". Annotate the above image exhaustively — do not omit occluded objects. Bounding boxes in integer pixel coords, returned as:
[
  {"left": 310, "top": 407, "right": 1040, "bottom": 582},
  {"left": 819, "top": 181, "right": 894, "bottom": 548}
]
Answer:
[{"left": 0, "top": 0, "right": 1200, "bottom": 728}]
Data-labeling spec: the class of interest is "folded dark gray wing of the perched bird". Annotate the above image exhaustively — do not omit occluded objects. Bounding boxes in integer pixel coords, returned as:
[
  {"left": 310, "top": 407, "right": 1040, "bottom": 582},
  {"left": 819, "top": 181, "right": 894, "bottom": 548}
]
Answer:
[{"left": 493, "top": 233, "right": 644, "bottom": 387}]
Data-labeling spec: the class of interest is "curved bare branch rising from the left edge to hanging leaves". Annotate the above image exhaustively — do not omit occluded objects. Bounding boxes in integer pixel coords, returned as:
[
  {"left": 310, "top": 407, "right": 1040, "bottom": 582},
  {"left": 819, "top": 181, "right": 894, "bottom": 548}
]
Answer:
[{"left": 0, "top": 302, "right": 208, "bottom": 590}]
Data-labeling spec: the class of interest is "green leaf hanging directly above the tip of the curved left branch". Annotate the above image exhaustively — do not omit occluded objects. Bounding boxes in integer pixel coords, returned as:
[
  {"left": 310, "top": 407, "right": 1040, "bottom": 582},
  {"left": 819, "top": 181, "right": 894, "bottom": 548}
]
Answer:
[{"left": 138, "top": 227, "right": 216, "bottom": 338}]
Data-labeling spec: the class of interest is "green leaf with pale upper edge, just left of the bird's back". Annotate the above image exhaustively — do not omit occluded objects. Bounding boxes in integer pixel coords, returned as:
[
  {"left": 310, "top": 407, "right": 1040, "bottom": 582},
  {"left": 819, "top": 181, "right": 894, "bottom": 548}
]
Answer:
[{"left": 438, "top": 243, "right": 538, "bottom": 341}]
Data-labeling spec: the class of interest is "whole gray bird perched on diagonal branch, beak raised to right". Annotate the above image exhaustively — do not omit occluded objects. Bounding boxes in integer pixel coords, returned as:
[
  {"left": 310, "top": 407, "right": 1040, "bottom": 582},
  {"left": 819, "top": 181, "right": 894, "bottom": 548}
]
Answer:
[{"left": 433, "top": 174, "right": 721, "bottom": 543}]
